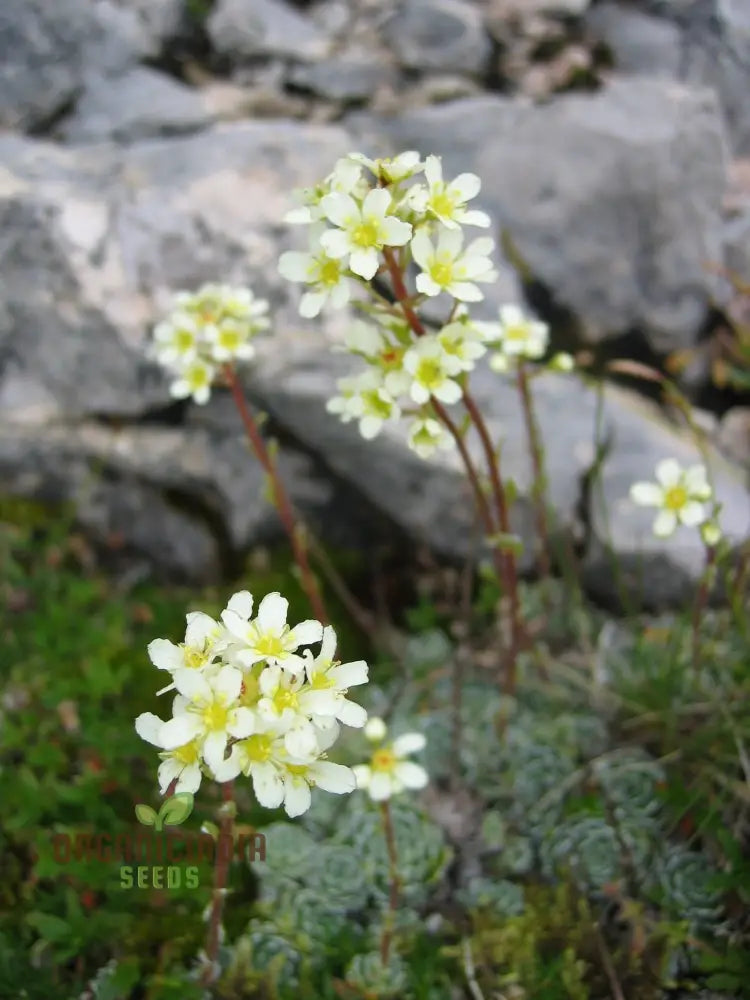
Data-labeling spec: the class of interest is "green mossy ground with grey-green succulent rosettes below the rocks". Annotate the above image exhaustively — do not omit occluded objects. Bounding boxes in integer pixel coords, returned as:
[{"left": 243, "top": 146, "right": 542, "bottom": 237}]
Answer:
[{"left": 0, "top": 508, "right": 750, "bottom": 1000}]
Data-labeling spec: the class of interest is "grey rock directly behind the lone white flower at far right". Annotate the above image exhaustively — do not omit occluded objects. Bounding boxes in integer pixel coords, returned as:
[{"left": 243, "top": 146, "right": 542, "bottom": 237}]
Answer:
[{"left": 583, "top": 387, "right": 750, "bottom": 609}]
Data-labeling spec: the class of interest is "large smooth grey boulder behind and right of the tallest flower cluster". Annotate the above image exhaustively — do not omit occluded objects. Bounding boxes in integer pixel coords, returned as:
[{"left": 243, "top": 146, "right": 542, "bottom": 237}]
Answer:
[{"left": 351, "top": 77, "right": 726, "bottom": 352}]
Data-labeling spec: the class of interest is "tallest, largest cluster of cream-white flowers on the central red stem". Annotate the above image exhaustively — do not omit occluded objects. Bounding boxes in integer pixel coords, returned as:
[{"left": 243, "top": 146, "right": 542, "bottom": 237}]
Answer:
[{"left": 279, "top": 150, "right": 571, "bottom": 458}]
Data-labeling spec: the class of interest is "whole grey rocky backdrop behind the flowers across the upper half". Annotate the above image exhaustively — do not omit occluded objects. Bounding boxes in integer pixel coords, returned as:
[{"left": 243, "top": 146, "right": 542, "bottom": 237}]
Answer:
[{"left": 0, "top": 0, "right": 750, "bottom": 605}]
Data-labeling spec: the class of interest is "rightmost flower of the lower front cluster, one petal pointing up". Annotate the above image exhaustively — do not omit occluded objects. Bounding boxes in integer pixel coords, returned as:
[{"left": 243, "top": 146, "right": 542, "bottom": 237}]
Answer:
[{"left": 300, "top": 625, "right": 367, "bottom": 729}]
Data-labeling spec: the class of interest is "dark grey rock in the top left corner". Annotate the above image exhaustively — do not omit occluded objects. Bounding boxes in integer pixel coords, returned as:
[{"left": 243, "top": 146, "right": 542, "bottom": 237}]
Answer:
[{"left": 0, "top": 0, "right": 94, "bottom": 131}]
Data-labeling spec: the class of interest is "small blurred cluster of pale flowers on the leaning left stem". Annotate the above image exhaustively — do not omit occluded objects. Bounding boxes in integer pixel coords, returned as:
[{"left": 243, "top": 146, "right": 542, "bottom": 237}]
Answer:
[{"left": 152, "top": 284, "right": 269, "bottom": 403}]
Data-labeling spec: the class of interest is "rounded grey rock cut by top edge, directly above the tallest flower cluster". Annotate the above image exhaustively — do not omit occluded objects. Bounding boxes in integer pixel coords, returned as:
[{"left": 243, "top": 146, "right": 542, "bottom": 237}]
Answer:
[{"left": 383, "top": 0, "right": 492, "bottom": 76}]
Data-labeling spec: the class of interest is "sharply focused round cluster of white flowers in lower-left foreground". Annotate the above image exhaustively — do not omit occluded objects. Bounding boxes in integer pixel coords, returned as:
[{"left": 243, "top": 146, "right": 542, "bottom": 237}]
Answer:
[{"left": 135, "top": 591, "right": 368, "bottom": 816}]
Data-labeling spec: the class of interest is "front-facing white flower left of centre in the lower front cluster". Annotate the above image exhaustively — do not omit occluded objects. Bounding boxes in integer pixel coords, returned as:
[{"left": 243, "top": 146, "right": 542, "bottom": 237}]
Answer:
[{"left": 159, "top": 666, "right": 255, "bottom": 770}]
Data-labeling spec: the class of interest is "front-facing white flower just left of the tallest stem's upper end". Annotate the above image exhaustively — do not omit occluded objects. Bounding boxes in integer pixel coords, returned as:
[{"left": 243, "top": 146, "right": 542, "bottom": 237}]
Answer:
[{"left": 320, "top": 188, "right": 412, "bottom": 281}]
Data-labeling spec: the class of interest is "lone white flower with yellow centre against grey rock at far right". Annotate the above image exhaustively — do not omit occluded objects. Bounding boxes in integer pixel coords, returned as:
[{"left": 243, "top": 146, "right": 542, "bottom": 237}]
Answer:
[{"left": 630, "top": 458, "right": 712, "bottom": 538}]
